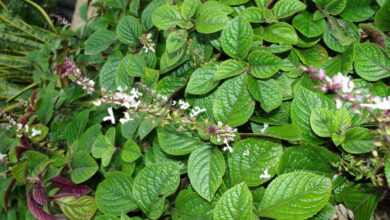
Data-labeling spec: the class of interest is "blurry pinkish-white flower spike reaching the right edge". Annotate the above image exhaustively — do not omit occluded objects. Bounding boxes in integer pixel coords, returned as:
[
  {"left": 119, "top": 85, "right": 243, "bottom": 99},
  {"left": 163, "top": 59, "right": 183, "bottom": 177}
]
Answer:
[{"left": 302, "top": 67, "right": 390, "bottom": 112}]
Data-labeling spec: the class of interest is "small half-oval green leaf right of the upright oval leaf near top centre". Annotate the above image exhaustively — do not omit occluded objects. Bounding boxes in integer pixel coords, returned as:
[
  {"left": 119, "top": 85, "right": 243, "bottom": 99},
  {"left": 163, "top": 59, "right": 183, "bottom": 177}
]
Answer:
[{"left": 263, "top": 22, "right": 298, "bottom": 45}]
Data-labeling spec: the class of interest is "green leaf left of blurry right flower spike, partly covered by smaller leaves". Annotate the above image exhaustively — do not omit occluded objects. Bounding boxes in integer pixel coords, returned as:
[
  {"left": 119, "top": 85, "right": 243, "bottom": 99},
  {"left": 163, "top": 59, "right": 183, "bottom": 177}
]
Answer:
[{"left": 291, "top": 87, "right": 333, "bottom": 143}]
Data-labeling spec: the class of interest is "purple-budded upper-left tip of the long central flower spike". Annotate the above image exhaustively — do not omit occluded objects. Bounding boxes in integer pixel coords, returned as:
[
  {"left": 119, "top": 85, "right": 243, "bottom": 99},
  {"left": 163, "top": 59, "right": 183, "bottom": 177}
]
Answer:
[{"left": 65, "top": 57, "right": 95, "bottom": 94}]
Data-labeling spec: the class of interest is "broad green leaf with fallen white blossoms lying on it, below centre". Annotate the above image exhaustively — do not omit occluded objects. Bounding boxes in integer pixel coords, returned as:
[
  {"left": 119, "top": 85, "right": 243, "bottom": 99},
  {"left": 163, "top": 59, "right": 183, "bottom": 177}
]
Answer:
[{"left": 228, "top": 138, "right": 283, "bottom": 186}]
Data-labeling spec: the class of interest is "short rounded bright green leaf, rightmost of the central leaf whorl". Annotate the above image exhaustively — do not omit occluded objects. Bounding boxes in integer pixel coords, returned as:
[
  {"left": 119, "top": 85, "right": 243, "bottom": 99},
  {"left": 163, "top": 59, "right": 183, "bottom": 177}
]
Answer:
[{"left": 248, "top": 51, "right": 282, "bottom": 79}]
